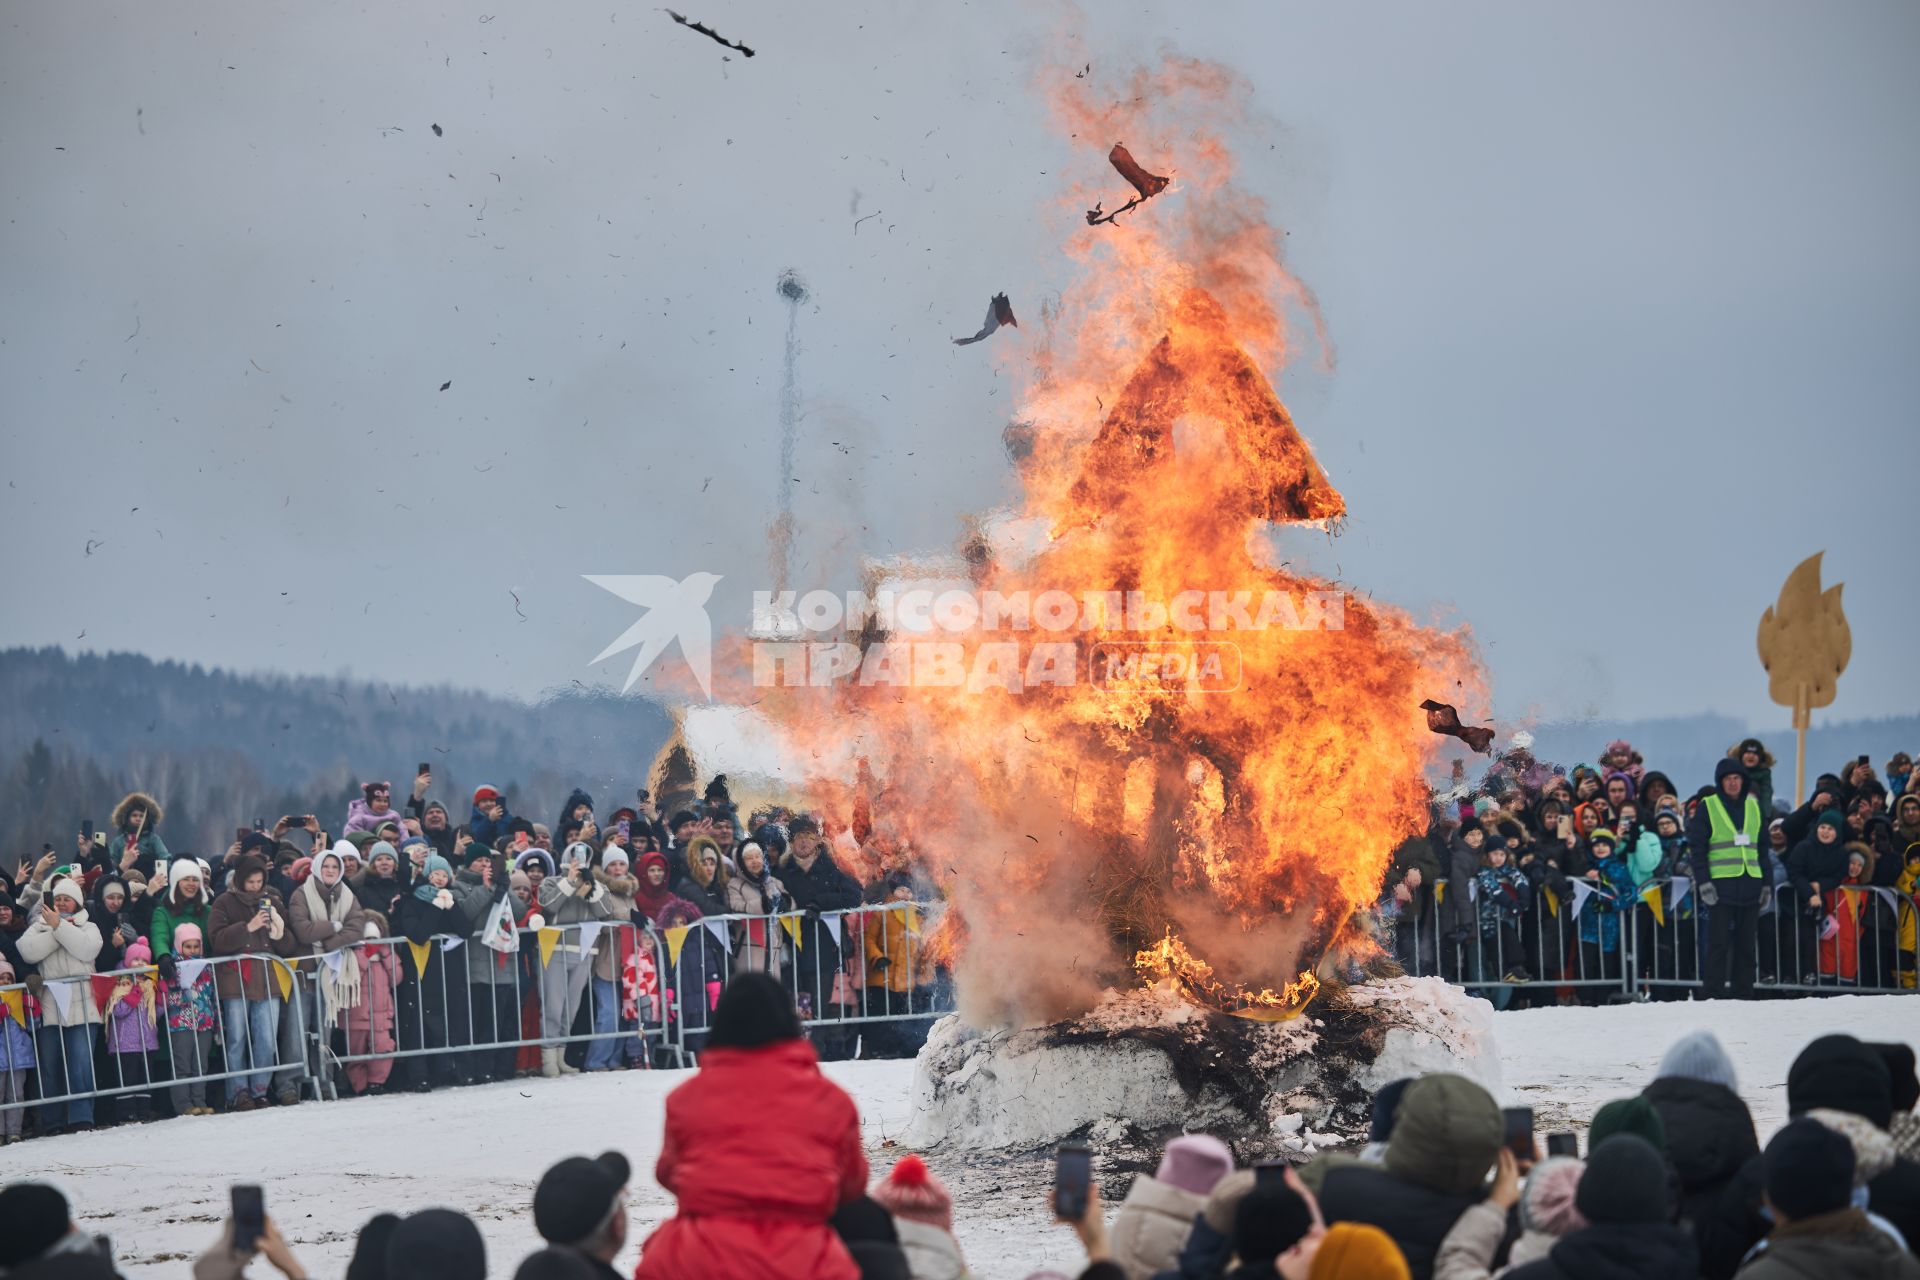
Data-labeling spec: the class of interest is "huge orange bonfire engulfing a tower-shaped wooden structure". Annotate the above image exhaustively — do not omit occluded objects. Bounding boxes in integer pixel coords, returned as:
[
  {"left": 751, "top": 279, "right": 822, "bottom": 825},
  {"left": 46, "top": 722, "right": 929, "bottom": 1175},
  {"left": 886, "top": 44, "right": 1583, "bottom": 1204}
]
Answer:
[{"left": 733, "top": 61, "right": 1478, "bottom": 1025}]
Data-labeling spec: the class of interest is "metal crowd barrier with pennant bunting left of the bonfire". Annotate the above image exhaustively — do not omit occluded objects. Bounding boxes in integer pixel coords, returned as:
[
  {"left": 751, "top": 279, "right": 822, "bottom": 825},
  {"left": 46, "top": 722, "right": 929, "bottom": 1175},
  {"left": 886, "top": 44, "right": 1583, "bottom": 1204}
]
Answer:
[{"left": 0, "top": 902, "right": 954, "bottom": 1134}]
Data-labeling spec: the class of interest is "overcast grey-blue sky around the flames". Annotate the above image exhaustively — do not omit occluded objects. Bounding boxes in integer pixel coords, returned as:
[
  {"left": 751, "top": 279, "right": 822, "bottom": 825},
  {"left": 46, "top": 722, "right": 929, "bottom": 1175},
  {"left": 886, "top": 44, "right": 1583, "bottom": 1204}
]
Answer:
[{"left": 0, "top": 0, "right": 1920, "bottom": 723}]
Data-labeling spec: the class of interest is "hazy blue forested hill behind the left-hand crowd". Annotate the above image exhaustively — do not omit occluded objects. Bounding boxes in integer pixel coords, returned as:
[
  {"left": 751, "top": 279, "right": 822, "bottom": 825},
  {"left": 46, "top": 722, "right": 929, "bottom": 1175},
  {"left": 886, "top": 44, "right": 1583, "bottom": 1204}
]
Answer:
[{"left": 0, "top": 649, "right": 672, "bottom": 862}]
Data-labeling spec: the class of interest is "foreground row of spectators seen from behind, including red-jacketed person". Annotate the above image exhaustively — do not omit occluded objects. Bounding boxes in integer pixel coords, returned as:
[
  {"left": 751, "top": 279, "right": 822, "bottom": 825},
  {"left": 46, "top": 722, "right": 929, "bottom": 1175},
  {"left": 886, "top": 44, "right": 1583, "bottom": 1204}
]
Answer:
[{"left": 0, "top": 973, "right": 1920, "bottom": 1280}]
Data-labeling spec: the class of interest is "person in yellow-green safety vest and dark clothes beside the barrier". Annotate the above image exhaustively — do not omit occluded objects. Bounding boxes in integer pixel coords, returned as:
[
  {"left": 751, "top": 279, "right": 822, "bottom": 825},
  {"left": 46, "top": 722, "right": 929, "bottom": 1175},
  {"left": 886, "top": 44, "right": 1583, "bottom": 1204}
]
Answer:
[{"left": 1688, "top": 760, "right": 1774, "bottom": 1000}]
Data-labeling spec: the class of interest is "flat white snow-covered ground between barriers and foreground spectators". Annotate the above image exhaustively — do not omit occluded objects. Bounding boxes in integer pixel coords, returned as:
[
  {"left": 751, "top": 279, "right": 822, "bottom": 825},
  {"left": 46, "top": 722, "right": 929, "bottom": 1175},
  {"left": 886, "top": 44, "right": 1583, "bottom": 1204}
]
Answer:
[{"left": 0, "top": 996, "right": 1920, "bottom": 1278}]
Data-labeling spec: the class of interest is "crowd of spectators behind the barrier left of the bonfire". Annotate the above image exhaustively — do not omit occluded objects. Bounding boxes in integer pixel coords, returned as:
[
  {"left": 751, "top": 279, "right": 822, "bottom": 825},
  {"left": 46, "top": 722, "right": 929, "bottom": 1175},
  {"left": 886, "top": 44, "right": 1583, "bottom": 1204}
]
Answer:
[{"left": 0, "top": 771, "right": 947, "bottom": 1142}]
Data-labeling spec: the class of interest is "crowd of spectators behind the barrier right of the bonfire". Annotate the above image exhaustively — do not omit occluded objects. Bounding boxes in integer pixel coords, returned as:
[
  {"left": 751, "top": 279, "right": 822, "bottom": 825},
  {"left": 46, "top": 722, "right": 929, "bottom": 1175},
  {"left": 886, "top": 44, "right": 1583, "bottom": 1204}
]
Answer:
[{"left": 1373, "top": 735, "right": 1920, "bottom": 1007}]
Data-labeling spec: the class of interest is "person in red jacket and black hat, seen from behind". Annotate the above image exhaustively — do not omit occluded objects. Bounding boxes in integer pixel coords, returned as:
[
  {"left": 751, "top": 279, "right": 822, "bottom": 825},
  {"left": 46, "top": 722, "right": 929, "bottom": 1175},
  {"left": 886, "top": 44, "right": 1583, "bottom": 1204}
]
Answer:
[{"left": 634, "top": 973, "right": 866, "bottom": 1280}]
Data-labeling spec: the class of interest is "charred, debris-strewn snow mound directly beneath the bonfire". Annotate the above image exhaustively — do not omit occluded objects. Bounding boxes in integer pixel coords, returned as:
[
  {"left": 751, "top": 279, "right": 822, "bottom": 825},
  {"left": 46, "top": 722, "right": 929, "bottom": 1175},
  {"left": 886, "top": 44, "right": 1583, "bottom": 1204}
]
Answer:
[{"left": 904, "top": 977, "right": 1500, "bottom": 1159}]
